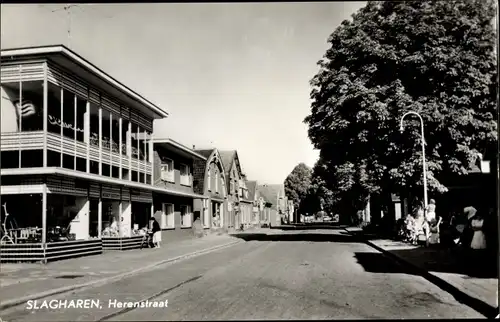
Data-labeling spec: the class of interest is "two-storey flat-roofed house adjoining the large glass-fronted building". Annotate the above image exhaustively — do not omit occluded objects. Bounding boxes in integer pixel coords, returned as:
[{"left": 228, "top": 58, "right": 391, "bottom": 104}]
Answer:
[{"left": 153, "top": 138, "right": 208, "bottom": 241}]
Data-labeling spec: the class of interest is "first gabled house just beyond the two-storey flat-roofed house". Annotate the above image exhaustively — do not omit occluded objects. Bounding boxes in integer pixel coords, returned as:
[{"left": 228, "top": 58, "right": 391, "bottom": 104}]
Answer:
[{"left": 193, "top": 149, "right": 231, "bottom": 229}]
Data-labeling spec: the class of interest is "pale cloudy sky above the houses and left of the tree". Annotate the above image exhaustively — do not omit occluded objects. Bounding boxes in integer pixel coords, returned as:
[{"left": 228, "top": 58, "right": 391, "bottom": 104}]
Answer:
[{"left": 1, "top": 2, "right": 365, "bottom": 184}]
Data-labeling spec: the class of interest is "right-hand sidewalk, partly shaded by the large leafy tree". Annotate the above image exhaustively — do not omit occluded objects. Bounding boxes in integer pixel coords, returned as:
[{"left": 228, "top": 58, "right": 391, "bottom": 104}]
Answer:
[{"left": 346, "top": 228, "right": 498, "bottom": 318}]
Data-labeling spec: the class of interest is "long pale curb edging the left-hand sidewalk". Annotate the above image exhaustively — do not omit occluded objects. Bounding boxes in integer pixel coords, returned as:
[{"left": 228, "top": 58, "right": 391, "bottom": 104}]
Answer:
[{"left": 0, "top": 240, "right": 243, "bottom": 310}]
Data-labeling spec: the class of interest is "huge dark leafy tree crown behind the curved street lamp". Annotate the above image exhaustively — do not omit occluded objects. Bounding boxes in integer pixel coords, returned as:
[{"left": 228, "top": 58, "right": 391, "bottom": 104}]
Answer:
[{"left": 304, "top": 0, "right": 497, "bottom": 210}]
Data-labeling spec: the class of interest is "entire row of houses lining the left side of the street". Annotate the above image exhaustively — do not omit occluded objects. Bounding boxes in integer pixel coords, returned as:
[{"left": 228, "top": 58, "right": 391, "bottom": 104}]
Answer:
[{"left": 0, "top": 45, "right": 293, "bottom": 261}]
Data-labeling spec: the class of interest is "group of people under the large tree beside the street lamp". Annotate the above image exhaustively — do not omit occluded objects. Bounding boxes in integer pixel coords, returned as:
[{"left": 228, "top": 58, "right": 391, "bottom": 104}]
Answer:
[{"left": 400, "top": 199, "right": 486, "bottom": 249}]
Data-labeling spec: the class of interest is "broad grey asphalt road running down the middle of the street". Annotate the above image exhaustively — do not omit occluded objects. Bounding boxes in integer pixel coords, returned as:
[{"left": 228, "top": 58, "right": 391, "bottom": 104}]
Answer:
[{"left": 0, "top": 230, "right": 482, "bottom": 322}]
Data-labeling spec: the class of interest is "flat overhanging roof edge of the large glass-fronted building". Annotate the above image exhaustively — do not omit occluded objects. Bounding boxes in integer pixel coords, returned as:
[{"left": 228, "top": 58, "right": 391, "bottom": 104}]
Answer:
[{"left": 1, "top": 45, "right": 168, "bottom": 118}]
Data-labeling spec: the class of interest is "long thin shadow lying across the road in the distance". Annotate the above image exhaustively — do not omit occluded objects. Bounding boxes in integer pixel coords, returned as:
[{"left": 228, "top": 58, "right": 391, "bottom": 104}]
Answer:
[{"left": 231, "top": 233, "right": 362, "bottom": 243}]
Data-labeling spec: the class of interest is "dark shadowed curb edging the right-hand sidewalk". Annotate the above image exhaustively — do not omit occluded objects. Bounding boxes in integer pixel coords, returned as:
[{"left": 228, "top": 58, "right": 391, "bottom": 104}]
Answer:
[{"left": 345, "top": 229, "right": 498, "bottom": 319}]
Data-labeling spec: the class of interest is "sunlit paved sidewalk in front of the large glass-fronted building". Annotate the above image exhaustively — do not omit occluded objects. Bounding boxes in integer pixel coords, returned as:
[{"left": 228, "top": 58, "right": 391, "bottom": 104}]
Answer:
[{"left": 0, "top": 235, "right": 242, "bottom": 309}]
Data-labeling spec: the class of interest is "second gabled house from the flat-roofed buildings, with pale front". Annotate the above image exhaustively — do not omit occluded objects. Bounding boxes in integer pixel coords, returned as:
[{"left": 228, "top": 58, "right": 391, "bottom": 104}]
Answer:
[{"left": 220, "top": 150, "right": 253, "bottom": 229}]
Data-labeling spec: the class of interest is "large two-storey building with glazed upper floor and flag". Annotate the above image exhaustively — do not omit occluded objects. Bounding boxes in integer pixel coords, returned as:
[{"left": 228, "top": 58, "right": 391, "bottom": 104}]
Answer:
[{"left": 1, "top": 46, "right": 168, "bottom": 261}]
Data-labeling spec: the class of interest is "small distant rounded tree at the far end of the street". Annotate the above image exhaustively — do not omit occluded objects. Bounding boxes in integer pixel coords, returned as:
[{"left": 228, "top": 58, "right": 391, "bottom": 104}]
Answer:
[{"left": 285, "top": 163, "right": 312, "bottom": 209}]
